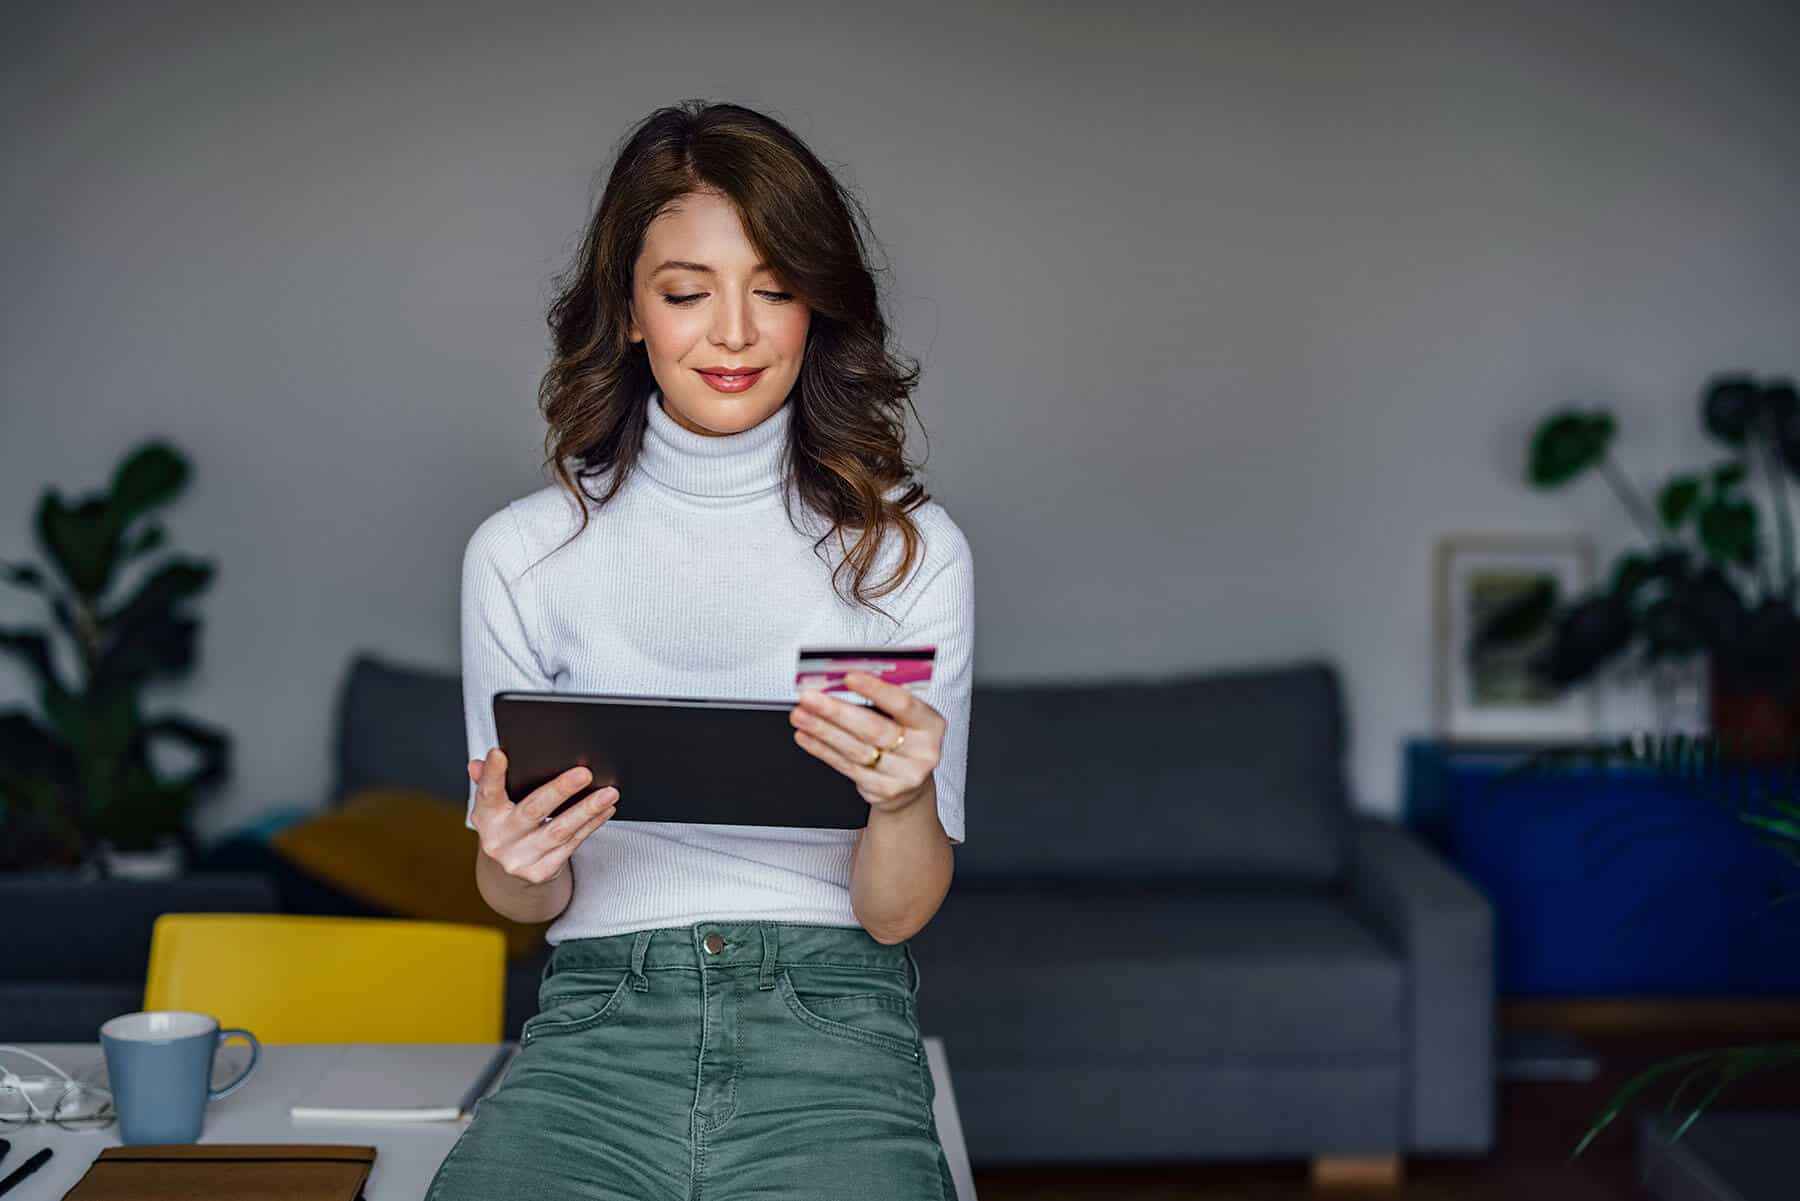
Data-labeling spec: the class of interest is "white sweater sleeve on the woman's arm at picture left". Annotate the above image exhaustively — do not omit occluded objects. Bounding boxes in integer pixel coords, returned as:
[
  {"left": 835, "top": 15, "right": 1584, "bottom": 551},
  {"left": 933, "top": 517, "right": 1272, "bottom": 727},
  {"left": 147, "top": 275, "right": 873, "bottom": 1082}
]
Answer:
[{"left": 461, "top": 506, "right": 553, "bottom": 828}]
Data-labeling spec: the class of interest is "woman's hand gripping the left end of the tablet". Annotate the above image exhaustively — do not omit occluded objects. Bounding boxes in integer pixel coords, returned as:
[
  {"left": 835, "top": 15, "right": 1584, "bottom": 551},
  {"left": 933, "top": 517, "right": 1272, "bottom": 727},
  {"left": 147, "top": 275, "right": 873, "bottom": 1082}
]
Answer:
[{"left": 468, "top": 747, "right": 619, "bottom": 884}]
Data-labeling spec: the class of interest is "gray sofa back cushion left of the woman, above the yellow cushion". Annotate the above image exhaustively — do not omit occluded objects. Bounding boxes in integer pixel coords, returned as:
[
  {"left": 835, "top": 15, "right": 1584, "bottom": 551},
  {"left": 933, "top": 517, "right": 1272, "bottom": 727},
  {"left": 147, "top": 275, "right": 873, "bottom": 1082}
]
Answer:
[{"left": 326, "top": 652, "right": 468, "bottom": 814}]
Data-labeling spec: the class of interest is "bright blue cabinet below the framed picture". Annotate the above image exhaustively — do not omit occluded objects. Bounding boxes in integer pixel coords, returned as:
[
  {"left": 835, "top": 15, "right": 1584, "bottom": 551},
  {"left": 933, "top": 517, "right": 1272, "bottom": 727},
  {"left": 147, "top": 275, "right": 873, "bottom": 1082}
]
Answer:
[{"left": 1404, "top": 738, "right": 1800, "bottom": 999}]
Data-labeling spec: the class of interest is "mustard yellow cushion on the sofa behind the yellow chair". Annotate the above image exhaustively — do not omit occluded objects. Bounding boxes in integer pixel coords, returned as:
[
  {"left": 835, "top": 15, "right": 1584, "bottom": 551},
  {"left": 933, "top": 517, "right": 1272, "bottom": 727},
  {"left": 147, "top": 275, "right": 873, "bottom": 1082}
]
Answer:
[{"left": 270, "top": 789, "right": 549, "bottom": 958}]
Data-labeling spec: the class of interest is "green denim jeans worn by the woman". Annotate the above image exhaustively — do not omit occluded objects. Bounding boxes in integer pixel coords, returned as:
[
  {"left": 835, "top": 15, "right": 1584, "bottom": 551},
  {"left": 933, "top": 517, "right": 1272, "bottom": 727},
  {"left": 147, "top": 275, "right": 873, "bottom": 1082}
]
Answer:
[{"left": 427, "top": 922, "right": 956, "bottom": 1201}]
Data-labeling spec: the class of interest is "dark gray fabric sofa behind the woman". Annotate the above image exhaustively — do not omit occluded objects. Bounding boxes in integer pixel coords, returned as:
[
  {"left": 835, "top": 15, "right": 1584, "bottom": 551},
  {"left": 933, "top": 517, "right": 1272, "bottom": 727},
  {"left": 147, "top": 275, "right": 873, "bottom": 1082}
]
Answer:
[{"left": 0, "top": 655, "right": 1494, "bottom": 1165}]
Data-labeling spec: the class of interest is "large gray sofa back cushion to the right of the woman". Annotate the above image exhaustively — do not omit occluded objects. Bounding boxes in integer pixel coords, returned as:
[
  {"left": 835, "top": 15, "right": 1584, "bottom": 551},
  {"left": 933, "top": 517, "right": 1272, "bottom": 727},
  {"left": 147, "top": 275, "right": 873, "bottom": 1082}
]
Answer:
[{"left": 956, "top": 663, "right": 1350, "bottom": 884}]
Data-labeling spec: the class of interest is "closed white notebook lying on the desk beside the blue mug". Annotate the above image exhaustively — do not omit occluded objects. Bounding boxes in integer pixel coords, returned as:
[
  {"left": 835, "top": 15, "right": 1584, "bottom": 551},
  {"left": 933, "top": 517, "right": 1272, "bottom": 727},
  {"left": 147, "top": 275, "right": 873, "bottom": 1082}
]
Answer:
[{"left": 288, "top": 1043, "right": 517, "bottom": 1122}]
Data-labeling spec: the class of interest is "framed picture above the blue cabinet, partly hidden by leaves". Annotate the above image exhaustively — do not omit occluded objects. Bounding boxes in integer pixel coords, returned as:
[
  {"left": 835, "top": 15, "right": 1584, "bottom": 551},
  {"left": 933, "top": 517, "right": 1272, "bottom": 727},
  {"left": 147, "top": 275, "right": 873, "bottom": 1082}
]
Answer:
[{"left": 1433, "top": 533, "right": 1598, "bottom": 742}]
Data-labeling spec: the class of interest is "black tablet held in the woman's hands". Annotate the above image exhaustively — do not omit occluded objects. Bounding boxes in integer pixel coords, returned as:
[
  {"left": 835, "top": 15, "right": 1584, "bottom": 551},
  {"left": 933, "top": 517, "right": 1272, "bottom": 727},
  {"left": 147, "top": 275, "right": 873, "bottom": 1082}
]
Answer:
[{"left": 493, "top": 691, "right": 869, "bottom": 830}]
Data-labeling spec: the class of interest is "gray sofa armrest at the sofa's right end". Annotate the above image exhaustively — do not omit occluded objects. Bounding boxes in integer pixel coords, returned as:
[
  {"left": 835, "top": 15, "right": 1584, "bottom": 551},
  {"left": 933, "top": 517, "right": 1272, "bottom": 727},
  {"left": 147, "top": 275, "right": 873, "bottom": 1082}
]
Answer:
[{"left": 1348, "top": 821, "right": 1496, "bottom": 1152}]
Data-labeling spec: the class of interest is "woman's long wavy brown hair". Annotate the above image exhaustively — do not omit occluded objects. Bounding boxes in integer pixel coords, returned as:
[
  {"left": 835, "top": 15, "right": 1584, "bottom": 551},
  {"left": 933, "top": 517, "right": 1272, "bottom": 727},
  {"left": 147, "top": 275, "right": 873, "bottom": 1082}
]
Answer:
[{"left": 538, "top": 101, "right": 931, "bottom": 626}]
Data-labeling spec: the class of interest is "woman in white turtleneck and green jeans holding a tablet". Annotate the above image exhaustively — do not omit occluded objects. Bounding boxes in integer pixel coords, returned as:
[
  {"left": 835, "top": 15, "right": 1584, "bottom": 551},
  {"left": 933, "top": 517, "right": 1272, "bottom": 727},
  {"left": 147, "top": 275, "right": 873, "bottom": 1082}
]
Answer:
[{"left": 428, "top": 101, "right": 974, "bottom": 1201}]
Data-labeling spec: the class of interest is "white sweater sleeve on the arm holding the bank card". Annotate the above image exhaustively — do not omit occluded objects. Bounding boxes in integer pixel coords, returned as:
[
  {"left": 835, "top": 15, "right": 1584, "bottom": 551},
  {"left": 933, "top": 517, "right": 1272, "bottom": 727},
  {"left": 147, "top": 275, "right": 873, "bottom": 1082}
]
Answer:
[{"left": 893, "top": 504, "right": 976, "bottom": 846}]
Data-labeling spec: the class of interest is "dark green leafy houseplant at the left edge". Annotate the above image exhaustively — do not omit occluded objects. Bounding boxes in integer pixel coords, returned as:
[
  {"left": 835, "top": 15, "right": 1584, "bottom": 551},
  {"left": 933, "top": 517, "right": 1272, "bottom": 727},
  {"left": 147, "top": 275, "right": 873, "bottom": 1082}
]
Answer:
[{"left": 0, "top": 439, "right": 230, "bottom": 870}]
